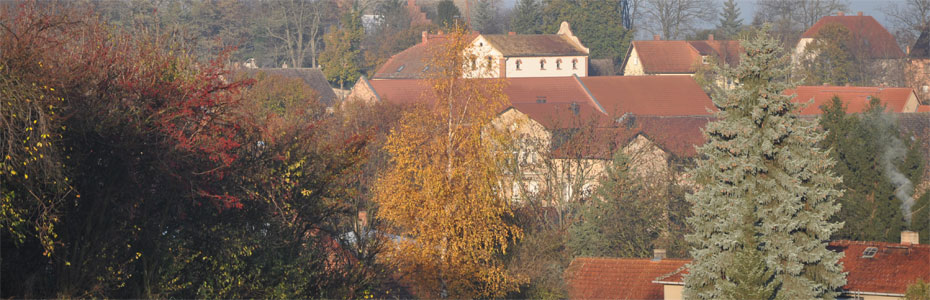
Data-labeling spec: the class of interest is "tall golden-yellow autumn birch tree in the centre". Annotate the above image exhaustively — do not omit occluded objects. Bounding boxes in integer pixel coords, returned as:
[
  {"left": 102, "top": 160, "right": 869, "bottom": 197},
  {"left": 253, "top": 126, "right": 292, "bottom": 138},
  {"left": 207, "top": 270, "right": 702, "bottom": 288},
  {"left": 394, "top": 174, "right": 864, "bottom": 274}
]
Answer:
[{"left": 376, "top": 29, "right": 525, "bottom": 298}]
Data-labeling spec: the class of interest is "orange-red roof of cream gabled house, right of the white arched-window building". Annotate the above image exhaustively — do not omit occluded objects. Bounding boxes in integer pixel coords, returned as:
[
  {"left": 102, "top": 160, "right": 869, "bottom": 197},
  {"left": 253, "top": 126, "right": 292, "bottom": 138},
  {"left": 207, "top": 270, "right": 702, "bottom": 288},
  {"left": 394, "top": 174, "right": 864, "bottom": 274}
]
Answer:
[{"left": 621, "top": 40, "right": 742, "bottom": 74}]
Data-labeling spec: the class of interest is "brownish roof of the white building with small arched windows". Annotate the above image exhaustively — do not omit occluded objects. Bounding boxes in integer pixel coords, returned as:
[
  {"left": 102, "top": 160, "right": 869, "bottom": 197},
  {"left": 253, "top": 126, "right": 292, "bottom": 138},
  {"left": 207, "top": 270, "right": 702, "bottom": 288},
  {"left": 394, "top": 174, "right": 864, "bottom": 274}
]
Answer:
[{"left": 482, "top": 34, "right": 588, "bottom": 57}]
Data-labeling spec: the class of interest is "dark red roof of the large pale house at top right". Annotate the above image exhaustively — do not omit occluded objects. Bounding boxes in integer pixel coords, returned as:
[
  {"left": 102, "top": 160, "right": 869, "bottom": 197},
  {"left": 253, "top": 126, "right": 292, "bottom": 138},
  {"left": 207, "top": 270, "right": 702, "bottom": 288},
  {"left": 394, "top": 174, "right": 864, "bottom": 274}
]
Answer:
[{"left": 801, "top": 16, "right": 904, "bottom": 59}]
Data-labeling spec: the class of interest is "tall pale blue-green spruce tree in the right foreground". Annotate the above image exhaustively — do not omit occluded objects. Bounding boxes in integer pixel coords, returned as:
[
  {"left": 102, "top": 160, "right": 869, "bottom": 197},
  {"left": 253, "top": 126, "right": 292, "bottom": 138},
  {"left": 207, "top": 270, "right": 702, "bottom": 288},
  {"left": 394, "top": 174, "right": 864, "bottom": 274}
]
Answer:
[{"left": 685, "top": 27, "right": 846, "bottom": 299}]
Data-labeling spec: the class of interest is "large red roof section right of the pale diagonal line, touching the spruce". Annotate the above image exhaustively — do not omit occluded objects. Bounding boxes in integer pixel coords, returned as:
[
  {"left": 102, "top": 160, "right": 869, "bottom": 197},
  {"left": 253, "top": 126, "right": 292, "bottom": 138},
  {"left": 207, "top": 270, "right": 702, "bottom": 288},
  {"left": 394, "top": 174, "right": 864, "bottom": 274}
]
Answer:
[{"left": 580, "top": 75, "right": 716, "bottom": 116}]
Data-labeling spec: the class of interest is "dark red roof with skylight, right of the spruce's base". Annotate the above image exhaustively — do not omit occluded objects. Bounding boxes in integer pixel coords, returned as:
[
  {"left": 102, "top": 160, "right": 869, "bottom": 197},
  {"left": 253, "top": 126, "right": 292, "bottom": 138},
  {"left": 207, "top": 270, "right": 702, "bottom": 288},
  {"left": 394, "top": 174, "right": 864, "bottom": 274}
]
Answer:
[{"left": 829, "top": 241, "right": 930, "bottom": 295}]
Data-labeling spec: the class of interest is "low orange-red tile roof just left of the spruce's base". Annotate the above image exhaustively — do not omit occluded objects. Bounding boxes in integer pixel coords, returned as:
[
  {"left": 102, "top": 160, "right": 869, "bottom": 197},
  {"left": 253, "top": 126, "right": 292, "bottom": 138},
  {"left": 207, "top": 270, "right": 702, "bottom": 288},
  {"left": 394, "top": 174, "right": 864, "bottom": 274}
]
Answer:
[{"left": 565, "top": 257, "right": 689, "bottom": 299}]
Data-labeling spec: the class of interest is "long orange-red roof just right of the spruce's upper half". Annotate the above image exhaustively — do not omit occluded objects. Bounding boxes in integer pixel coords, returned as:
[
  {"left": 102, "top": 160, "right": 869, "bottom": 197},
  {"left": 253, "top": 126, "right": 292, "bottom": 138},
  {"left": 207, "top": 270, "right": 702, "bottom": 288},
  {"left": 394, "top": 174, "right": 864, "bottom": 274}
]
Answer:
[{"left": 785, "top": 85, "right": 914, "bottom": 115}]
